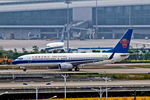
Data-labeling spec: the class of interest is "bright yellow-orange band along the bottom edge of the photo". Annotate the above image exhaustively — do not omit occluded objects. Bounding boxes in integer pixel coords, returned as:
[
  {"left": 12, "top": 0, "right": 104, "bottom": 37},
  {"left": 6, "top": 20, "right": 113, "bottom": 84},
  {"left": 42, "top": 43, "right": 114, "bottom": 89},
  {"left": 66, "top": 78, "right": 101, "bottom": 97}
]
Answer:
[{"left": 36, "top": 96, "right": 150, "bottom": 100}]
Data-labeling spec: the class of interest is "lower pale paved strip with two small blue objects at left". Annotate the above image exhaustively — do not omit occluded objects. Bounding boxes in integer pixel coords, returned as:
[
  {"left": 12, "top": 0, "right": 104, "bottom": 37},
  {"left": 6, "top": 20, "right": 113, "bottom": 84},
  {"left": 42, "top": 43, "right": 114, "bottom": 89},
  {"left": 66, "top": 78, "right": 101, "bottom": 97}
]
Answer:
[{"left": 0, "top": 80, "right": 150, "bottom": 89}]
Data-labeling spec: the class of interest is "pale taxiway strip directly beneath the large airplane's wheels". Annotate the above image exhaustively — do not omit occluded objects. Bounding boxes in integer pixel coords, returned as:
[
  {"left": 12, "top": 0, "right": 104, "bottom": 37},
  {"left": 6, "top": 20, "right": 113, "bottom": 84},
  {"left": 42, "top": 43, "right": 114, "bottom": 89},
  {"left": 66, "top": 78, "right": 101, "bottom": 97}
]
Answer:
[{"left": 0, "top": 68, "right": 150, "bottom": 74}]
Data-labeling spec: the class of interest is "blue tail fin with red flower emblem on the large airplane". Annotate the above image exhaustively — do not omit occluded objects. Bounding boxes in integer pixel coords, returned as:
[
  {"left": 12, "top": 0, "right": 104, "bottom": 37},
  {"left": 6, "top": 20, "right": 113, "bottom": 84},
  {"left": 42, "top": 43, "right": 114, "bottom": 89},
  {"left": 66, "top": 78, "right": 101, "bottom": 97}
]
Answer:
[{"left": 106, "top": 29, "right": 133, "bottom": 53}]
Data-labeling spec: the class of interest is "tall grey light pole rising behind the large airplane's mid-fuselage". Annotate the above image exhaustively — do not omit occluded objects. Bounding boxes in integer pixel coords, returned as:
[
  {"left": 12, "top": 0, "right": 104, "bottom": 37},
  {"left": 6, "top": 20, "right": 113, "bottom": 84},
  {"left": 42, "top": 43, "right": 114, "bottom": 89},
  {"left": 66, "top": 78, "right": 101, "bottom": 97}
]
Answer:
[{"left": 65, "top": 0, "right": 71, "bottom": 53}]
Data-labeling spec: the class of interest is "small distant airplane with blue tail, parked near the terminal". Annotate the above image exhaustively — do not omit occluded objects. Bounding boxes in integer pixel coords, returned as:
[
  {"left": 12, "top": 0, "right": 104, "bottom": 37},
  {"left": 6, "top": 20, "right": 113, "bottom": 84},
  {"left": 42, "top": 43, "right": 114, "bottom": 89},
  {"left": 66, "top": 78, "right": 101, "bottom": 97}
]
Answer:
[{"left": 45, "top": 27, "right": 65, "bottom": 50}]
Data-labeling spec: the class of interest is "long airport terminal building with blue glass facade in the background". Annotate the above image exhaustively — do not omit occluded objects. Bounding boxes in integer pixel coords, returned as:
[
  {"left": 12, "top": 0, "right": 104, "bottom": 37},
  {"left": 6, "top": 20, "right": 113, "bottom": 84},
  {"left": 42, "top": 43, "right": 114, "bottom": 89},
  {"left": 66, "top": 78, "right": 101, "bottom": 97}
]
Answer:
[{"left": 0, "top": 0, "right": 150, "bottom": 39}]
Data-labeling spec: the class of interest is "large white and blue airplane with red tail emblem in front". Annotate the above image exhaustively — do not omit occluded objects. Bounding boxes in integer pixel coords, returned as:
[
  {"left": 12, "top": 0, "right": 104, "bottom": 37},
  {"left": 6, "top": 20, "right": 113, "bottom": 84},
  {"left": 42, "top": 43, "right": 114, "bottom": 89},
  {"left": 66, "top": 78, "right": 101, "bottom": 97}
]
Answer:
[{"left": 12, "top": 29, "right": 133, "bottom": 71}]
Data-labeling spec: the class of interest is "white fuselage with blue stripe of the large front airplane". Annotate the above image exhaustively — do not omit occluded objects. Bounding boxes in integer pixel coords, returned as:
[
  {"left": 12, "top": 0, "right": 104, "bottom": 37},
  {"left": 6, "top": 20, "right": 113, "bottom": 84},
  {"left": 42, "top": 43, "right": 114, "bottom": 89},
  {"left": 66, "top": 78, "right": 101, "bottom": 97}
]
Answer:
[{"left": 13, "top": 53, "right": 129, "bottom": 67}]
